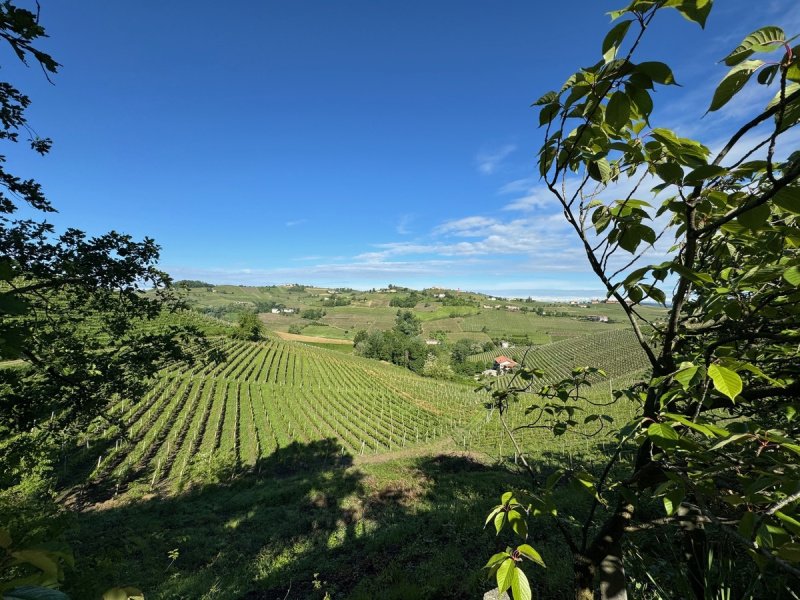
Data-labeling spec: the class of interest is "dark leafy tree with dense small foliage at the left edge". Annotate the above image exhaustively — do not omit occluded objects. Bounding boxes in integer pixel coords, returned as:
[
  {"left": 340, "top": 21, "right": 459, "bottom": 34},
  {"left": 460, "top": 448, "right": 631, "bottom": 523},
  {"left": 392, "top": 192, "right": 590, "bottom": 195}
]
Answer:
[{"left": 0, "top": 2, "right": 207, "bottom": 488}]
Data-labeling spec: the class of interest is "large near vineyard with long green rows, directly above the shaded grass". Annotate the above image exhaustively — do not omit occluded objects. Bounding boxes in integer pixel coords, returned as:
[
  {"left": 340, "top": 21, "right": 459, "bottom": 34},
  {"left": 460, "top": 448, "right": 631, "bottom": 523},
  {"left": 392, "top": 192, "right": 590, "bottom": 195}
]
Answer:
[{"left": 65, "top": 340, "right": 480, "bottom": 493}]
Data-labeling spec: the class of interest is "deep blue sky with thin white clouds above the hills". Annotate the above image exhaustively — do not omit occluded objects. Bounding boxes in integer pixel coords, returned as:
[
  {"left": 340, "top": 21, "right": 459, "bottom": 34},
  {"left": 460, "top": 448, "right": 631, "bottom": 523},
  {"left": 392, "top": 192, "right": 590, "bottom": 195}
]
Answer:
[{"left": 2, "top": 0, "right": 800, "bottom": 297}]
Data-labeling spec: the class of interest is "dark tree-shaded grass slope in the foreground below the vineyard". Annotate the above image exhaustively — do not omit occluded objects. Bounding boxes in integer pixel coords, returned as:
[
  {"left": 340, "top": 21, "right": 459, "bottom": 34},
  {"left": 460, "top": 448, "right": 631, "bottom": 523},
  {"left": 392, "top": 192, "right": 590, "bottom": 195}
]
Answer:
[{"left": 66, "top": 439, "right": 566, "bottom": 600}]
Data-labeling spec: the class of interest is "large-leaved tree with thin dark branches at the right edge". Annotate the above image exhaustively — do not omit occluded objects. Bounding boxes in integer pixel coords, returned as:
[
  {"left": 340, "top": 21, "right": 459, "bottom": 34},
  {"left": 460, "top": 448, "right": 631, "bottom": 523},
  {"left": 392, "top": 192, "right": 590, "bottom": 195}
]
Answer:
[{"left": 487, "top": 0, "right": 800, "bottom": 600}]
